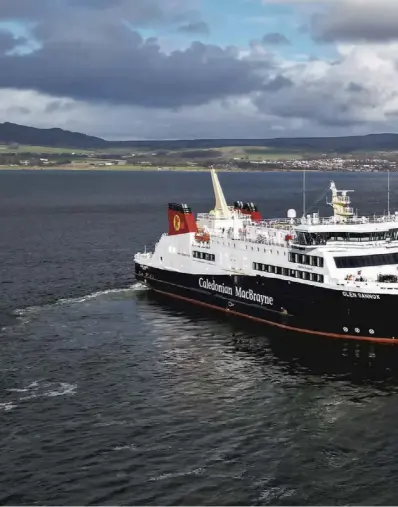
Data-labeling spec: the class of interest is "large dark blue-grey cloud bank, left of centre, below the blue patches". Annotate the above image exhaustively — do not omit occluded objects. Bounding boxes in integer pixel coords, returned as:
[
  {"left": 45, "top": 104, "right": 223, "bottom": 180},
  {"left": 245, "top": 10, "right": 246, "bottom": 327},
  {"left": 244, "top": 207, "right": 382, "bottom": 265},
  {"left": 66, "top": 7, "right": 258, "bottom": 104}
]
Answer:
[{"left": 0, "top": 24, "right": 269, "bottom": 108}]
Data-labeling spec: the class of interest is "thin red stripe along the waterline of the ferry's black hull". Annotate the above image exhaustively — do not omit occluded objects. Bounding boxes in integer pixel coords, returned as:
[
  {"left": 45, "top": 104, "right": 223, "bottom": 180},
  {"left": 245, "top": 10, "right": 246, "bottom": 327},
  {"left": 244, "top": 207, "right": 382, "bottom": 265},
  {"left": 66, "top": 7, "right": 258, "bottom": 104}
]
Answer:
[{"left": 152, "top": 288, "right": 398, "bottom": 345}]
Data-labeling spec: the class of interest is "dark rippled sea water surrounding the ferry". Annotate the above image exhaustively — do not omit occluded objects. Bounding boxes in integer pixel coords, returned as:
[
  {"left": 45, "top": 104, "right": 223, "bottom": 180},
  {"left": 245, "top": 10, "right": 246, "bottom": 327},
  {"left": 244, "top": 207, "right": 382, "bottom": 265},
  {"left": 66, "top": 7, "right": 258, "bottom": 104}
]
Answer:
[{"left": 0, "top": 171, "right": 398, "bottom": 505}]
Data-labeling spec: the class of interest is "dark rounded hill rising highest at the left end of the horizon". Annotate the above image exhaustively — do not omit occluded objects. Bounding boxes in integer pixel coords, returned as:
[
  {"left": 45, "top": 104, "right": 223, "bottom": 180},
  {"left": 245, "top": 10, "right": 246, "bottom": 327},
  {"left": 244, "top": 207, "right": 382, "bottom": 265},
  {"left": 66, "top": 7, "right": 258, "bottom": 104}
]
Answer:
[{"left": 0, "top": 122, "right": 107, "bottom": 149}]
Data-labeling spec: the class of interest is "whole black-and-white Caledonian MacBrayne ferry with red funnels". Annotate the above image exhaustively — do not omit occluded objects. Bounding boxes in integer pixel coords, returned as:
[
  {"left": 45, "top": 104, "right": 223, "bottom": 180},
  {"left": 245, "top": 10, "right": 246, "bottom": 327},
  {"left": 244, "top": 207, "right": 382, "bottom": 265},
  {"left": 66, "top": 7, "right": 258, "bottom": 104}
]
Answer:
[{"left": 134, "top": 169, "right": 398, "bottom": 344}]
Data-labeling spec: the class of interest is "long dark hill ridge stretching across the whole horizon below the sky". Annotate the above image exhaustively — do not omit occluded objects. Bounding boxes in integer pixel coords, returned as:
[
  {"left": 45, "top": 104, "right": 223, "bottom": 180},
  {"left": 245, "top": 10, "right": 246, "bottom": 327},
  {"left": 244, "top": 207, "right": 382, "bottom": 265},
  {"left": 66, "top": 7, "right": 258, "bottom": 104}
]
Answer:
[{"left": 0, "top": 122, "right": 398, "bottom": 153}]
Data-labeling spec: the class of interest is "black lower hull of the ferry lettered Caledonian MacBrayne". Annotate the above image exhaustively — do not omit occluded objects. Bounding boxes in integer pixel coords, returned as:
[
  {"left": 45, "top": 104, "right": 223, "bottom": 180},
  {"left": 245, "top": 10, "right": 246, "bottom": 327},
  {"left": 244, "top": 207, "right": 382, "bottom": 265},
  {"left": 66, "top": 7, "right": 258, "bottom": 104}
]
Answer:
[{"left": 135, "top": 263, "right": 398, "bottom": 345}]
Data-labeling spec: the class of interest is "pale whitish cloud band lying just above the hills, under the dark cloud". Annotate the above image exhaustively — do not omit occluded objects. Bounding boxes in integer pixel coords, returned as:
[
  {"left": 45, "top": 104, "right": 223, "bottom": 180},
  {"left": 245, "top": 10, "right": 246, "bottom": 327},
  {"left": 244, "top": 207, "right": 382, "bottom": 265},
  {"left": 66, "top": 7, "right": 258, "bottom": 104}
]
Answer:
[{"left": 0, "top": 82, "right": 397, "bottom": 140}]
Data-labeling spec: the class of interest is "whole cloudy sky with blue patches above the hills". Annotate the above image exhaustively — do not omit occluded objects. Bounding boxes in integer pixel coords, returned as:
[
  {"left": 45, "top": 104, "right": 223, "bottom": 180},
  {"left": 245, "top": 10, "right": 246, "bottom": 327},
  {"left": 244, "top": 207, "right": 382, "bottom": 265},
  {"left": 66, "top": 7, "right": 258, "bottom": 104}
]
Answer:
[{"left": 0, "top": 0, "right": 398, "bottom": 140}]
